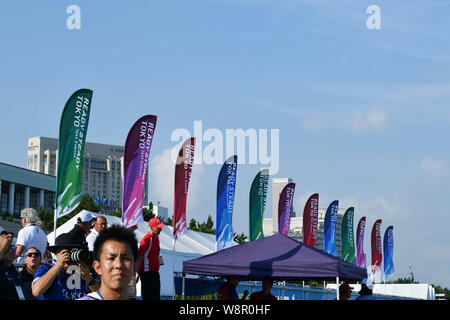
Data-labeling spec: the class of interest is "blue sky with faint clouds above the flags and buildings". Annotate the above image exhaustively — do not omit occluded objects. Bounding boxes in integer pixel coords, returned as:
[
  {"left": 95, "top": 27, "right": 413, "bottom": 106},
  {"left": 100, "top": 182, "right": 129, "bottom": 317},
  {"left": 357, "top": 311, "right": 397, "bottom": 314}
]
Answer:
[{"left": 0, "top": 0, "right": 450, "bottom": 287}]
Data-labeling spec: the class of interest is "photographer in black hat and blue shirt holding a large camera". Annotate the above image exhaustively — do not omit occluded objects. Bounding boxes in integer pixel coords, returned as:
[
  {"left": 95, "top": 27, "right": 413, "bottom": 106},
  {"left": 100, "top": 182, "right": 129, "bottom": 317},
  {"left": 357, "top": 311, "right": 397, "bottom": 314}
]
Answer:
[{"left": 32, "top": 233, "right": 99, "bottom": 300}]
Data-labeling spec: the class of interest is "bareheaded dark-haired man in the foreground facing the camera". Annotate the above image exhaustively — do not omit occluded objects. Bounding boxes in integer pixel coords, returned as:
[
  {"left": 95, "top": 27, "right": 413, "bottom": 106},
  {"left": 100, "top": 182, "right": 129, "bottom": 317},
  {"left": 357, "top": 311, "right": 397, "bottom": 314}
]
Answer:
[{"left": 80, "top": 225, "right": 138, "bottom": 300}]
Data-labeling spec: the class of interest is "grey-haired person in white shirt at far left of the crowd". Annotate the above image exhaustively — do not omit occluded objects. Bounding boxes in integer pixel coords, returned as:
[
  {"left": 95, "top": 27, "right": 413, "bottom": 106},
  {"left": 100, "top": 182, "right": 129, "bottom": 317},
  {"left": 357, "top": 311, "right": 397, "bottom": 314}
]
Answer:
[{"left": 16, "top": 208, "right": 47, "bottom": 264}]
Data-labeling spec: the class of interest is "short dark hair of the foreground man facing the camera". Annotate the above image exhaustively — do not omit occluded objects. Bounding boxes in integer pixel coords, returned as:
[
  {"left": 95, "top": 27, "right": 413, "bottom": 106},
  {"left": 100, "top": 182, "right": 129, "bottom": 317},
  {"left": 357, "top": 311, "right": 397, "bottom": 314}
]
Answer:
[{"left": 94, "top": 224, "right": 138, "bottom": 261}]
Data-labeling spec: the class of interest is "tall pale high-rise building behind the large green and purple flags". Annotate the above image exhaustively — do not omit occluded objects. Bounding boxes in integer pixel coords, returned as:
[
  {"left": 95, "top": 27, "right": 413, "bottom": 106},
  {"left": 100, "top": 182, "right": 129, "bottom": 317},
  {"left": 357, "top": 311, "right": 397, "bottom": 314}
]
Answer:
[{"left": 28, "top": 137, "right": 148, "bottom": 211}]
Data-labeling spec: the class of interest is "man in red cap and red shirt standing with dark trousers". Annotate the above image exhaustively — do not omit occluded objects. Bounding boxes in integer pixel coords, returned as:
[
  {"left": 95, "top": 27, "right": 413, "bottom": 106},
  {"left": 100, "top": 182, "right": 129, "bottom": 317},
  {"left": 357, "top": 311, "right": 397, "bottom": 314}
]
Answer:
[{"left": 136, "top": 218, "right": 165, "bottom": 300}]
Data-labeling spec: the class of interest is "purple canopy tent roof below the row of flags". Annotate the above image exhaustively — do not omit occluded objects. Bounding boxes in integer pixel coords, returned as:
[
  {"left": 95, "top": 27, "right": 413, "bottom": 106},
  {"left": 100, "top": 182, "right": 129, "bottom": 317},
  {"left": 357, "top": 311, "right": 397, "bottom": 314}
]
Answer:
[{"left": 183, "top": 234, "right": 367, "bottom": 298}]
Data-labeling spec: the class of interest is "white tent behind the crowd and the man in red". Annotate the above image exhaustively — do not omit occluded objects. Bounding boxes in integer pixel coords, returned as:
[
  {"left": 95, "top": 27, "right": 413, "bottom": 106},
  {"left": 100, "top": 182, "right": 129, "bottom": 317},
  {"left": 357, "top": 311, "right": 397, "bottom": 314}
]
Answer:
[{"left": 47, "top": 212, "right": 230, "bottom": 297}]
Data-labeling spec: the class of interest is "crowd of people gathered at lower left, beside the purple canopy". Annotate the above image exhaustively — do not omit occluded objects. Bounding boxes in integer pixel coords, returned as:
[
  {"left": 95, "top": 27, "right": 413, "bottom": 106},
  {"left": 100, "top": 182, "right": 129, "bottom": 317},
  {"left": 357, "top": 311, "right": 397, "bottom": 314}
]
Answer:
[{"left": 0, "top": 208, "right": 169, "bottom": 300}]
